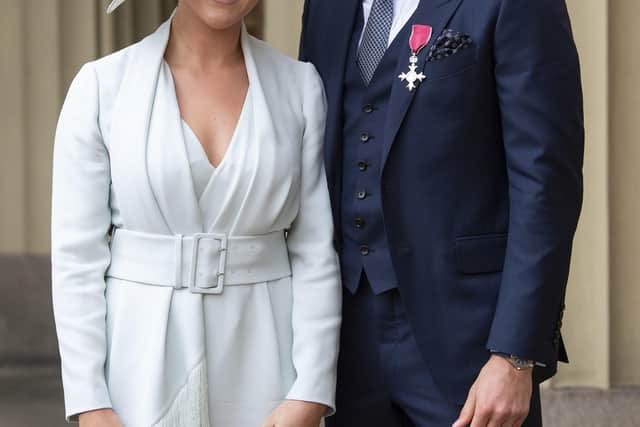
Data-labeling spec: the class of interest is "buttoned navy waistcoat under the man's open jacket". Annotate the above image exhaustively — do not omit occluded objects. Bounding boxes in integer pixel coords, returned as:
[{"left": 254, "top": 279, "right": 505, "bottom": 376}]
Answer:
[{"left": 340, "top": 11, "right": 409, "bottom": 294}]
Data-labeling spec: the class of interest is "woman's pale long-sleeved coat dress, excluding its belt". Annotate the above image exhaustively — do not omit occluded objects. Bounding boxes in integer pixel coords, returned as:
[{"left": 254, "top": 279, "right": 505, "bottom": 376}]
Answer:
[{"left": 52, "top": 13, "right": 341, "bottom": 427}]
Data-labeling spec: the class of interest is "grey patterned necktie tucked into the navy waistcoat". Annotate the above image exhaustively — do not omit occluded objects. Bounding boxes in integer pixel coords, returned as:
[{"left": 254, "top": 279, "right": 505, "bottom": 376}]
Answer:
[{"left": 358, "top": 0, "right": 393, "bottom": 85}]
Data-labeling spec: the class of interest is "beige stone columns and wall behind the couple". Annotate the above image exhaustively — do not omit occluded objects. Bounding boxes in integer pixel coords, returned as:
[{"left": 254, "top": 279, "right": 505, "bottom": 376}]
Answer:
[{"left": 0, "top": 0, "right": 640, "bottom": 426}]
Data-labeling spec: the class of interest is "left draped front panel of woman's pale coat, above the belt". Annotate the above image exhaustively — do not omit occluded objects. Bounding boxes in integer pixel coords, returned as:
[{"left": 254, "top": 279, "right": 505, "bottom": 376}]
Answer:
[{"left": 110, "top": 16, "right": 202, "bottom": 234}]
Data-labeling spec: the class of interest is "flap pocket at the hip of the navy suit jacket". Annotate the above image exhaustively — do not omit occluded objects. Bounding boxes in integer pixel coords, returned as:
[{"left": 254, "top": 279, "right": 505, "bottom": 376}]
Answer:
[{"left": 455, "top": 233, "right": 507, "bottom": 274}]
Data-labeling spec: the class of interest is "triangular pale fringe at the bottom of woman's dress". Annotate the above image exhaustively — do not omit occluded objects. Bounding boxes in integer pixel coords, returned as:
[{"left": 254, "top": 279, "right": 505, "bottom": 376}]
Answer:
[{"left": 153, "top": 359, "right": 210, "bottom": 427}]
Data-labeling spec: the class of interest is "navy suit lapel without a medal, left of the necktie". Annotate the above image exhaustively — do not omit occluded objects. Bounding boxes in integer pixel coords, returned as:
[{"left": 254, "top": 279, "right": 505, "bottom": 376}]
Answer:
[{"left": 314, "top": 0, "right": 362, "bottom": 185}]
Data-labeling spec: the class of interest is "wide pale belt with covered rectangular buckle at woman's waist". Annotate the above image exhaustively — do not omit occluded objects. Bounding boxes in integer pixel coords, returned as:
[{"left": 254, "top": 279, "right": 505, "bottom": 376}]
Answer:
[{"left": 106, "top": 229, "right": 291, "bottom": 294}]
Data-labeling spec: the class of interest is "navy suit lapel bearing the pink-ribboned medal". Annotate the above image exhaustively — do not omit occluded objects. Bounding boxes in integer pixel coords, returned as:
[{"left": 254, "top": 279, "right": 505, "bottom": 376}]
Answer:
[{"left": 382, "top": 0, "right": 462, "bottom": 169}]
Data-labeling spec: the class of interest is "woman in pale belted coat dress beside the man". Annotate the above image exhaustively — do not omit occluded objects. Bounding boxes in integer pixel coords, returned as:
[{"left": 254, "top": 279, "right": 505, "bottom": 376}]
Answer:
[{"left": 52, "top": 0, "right": 341, "bottom": 427}]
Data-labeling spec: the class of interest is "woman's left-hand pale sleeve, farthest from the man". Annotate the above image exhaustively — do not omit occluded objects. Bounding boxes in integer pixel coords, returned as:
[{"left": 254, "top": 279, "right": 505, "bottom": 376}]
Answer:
[{"left": 51, "top": 64, "right": 111, "bottom": 421}]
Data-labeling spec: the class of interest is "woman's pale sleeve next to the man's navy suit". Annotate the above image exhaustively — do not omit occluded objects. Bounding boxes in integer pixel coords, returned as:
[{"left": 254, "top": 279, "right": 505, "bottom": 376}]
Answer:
[{"left": 287, "top": 64, "right": 342, "bottom": 409}]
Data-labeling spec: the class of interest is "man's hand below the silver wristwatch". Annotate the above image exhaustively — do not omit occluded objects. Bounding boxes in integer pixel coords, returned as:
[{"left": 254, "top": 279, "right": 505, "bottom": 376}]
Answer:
[{"left": 453, "top": 355, "right": 533, "bottom": 427}]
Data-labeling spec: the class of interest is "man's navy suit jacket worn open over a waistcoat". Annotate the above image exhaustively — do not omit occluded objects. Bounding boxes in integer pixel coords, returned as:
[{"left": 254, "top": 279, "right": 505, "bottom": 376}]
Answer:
[{"left": 300, "top": 0, "right": 584, "bottom": 403}]
